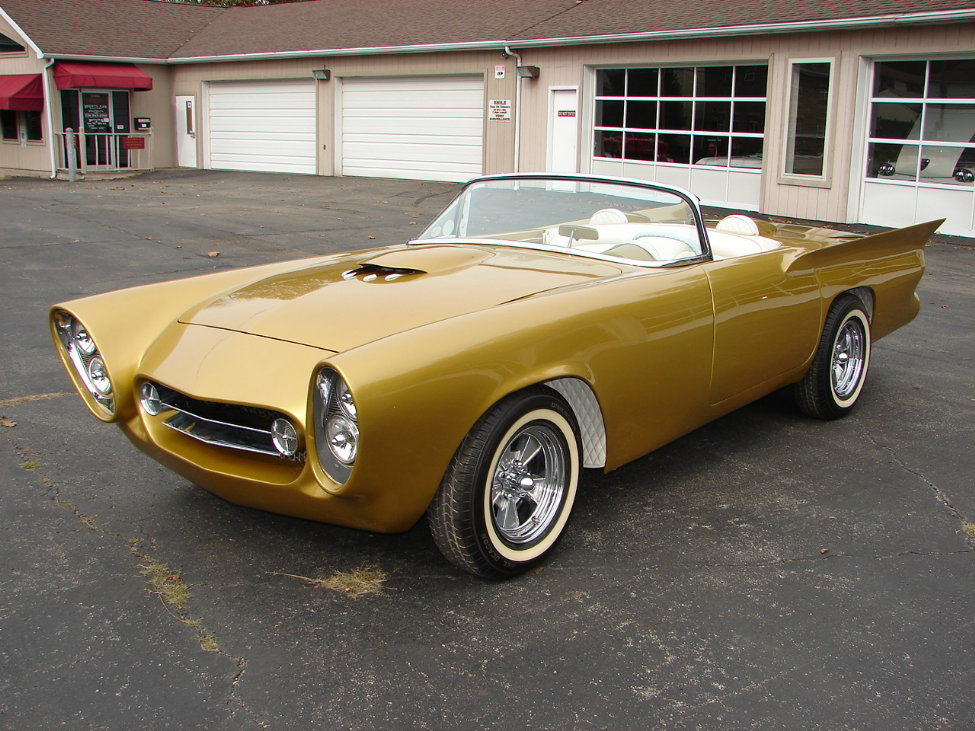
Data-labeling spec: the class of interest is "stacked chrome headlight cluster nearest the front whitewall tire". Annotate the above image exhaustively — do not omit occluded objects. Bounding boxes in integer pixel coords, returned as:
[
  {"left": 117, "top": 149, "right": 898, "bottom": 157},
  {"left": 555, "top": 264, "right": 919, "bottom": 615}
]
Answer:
[{"left": 314, "top": 368, "right": 359, "bottom": 483}]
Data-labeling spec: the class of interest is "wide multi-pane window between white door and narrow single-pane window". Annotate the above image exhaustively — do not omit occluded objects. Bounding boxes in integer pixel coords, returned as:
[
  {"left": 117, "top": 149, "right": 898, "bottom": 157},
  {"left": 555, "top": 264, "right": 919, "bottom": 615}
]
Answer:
[{"left": 593, "top": 65, "right": 768, "bottom": 168}]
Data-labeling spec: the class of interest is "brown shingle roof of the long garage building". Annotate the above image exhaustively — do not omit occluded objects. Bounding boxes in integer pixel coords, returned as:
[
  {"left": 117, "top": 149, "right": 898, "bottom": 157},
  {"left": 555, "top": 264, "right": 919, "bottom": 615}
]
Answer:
[{"left": 0, "top": 0, "right": 975, "bottom": 62}]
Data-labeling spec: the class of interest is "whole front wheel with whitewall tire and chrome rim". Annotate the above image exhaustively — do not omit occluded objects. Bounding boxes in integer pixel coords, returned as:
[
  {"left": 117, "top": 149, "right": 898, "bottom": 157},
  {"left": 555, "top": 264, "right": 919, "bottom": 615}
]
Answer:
[{"left": 427, "top": 389, "right": 581, "bottom": 578}]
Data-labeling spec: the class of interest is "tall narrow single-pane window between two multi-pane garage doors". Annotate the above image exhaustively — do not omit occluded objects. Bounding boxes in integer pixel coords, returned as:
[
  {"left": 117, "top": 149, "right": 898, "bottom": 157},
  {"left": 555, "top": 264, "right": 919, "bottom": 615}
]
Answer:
[{"left": 785, "top": 61, "right": 832, "bottom": 177}]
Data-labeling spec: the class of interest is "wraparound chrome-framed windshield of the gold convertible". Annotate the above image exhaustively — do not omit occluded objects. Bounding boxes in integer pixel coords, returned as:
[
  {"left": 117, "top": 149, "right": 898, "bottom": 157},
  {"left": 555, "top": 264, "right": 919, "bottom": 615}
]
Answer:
[{"left": 417, "top": 178, "right": 702, "bottom": 266}]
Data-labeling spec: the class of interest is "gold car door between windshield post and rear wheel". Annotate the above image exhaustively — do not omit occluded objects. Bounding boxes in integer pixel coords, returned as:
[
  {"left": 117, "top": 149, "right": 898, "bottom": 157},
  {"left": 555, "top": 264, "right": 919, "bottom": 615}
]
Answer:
[{"left": 704, "top": 246, "right": 822, "bottom": 404}]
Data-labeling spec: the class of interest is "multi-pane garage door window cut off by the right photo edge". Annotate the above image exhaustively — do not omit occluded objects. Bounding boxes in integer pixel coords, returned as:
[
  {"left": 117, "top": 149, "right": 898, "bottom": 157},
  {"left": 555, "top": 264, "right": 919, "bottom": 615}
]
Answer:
[{"left": 866, "top": 59, "right": 975, "bottom": 188}]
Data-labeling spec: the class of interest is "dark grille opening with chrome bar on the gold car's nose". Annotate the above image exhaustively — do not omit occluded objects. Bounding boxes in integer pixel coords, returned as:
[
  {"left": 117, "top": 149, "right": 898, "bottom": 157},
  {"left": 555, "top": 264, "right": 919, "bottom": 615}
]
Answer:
[{"left": 147, "top": 383, "right": 305, "bottom": 462}]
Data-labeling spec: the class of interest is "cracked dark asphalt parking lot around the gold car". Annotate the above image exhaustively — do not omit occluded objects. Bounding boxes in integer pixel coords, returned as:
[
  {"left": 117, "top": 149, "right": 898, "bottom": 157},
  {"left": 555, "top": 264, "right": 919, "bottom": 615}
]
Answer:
[{"left": 0, "top": 171, "right": 975, "bottom": 729}]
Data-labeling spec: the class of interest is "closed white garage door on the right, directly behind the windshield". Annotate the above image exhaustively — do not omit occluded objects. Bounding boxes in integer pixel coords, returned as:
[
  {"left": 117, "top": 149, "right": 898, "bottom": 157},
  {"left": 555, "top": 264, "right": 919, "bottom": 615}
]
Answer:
[{"left": 342, "top": 76, "right": 484, "bottom": 182}]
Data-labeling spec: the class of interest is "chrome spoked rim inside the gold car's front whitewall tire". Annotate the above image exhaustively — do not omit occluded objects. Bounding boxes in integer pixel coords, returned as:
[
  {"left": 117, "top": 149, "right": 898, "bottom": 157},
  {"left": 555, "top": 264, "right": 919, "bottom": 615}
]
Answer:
[{"left": 491, "top": 423, "right": 569, "bottom": 545}]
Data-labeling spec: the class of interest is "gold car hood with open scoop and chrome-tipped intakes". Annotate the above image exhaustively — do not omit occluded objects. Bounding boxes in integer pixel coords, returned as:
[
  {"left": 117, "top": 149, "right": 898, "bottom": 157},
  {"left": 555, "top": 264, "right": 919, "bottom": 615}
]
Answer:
[{"left": 180, "top": 244, "right": 621, "bottom": 352}]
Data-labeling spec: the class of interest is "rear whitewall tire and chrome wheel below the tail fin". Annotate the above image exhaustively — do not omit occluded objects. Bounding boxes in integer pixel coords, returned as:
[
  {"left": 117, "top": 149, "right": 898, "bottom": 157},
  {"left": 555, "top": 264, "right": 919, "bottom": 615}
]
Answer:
[{"left": 795, "top": 294, "right": 871, "bottom": 419}]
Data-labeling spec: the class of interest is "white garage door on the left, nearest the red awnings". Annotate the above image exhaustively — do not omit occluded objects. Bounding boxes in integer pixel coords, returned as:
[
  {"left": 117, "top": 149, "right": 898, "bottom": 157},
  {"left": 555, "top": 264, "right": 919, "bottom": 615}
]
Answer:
[{"left": 208, "top": 79, "right": 317, "bottom": 175}]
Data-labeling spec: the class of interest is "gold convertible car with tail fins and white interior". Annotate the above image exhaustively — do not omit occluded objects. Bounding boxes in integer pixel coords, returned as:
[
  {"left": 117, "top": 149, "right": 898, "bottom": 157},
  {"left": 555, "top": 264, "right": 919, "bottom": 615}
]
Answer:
[{"left": 50, "top": 174, "right": 940, "bottom": 577}]
